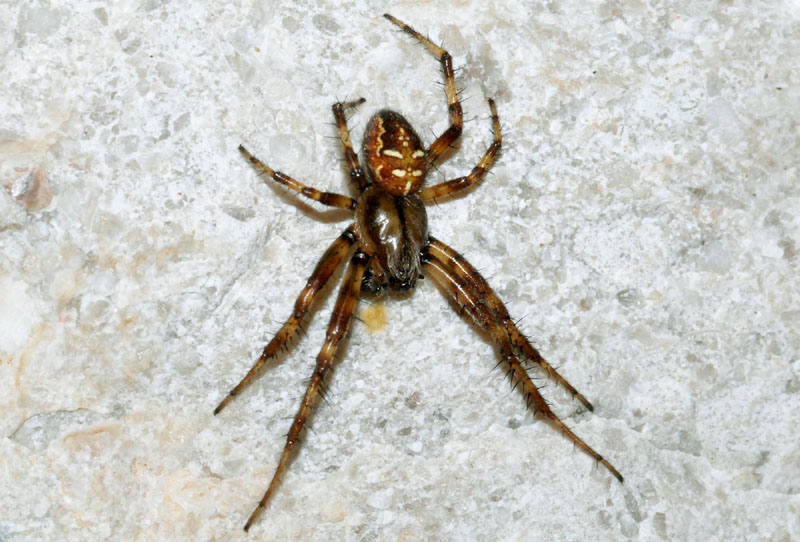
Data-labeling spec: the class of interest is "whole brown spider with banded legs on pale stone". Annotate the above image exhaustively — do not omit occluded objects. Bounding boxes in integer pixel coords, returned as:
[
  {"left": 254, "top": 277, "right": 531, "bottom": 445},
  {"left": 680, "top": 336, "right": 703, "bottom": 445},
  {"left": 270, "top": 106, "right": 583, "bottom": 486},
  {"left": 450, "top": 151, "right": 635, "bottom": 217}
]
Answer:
[{"left": 214, "top": 14, "right": 622, "bottom": 531}]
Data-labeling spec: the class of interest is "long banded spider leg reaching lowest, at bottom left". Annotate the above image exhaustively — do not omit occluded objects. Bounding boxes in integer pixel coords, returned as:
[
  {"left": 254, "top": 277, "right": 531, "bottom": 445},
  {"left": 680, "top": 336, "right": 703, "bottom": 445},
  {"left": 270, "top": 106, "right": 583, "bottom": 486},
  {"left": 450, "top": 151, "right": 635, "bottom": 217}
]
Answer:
[{"left": 244, "top": 250, "right": 370, "bottom": 531}]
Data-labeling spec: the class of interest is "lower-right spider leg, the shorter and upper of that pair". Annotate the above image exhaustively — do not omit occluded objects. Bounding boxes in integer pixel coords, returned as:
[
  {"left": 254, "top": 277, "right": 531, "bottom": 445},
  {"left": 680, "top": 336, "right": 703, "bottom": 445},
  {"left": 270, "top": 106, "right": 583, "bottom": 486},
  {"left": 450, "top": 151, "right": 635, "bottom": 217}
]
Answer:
[{"left": 427, "top": 236, "right": 594, "bottom": 410}]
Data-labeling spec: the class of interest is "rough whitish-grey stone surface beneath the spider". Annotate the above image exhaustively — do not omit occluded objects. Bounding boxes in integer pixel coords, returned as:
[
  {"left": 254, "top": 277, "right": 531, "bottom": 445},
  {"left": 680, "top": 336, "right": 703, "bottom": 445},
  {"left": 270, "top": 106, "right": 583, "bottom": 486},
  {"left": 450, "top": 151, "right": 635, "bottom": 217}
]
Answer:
[{"left": 0, "top": 0, "right": 800, "bottom": 542}]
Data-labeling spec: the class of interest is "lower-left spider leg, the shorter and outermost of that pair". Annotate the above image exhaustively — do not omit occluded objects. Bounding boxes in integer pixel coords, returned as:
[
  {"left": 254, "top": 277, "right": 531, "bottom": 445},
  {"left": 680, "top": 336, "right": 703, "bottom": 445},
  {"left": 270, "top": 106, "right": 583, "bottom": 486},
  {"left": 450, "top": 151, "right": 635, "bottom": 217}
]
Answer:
[{"left": 214, "top": 226, "right": 356, "bottom": 415}]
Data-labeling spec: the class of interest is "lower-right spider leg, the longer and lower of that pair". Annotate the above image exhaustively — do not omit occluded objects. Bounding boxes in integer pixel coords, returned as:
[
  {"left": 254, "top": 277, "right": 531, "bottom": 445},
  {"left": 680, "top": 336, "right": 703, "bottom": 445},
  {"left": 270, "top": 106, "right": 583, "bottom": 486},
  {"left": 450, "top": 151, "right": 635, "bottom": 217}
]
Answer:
[{"left": 423, "top": 249, "right": 623, "bottom": 482}]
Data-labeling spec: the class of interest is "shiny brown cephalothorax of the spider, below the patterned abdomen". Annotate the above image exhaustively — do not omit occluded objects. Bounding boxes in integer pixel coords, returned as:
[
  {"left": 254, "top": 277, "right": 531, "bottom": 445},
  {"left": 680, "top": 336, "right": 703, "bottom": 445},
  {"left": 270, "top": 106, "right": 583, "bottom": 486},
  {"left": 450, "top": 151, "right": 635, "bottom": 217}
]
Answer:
[{"left": 356, "top": 186, "right": 428, "bottom": 292}]
